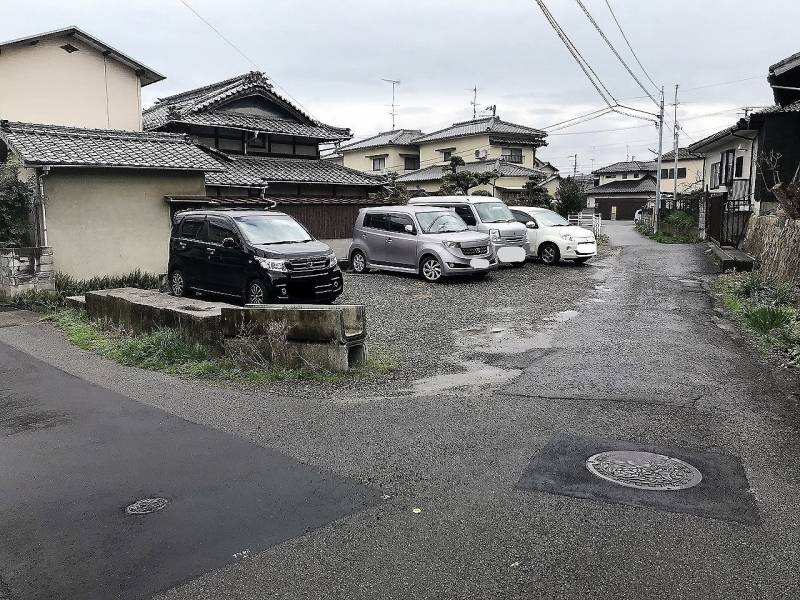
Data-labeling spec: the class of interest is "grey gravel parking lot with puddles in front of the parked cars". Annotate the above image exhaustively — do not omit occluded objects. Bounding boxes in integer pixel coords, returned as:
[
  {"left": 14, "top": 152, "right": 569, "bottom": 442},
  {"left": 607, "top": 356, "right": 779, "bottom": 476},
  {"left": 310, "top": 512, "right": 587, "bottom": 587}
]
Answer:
[{"left": 260, "top": 248, "right": 612, "bottom": 396}]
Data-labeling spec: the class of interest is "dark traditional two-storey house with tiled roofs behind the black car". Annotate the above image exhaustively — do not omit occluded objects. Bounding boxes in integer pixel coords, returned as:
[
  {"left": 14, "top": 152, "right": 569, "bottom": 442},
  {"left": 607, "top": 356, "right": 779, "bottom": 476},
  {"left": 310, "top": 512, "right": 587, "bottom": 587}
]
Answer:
[{"left": 144, "top": 71, "right": 382, "bottom": 238}]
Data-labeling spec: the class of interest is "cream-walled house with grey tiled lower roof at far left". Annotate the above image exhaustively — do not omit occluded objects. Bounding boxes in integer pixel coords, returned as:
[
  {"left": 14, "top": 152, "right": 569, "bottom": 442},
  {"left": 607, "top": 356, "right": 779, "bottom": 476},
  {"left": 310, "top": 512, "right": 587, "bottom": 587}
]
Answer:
[{"left": 0, "top": 27, "right": 224, "bottom": 284}]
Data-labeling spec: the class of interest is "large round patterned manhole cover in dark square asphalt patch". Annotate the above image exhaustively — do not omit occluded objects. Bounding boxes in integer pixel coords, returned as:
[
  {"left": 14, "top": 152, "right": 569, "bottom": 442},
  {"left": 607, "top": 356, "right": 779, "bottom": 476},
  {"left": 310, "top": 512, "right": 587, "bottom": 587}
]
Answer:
[{"left": 586, "top": 450, "right": 703, "bottom": 491}]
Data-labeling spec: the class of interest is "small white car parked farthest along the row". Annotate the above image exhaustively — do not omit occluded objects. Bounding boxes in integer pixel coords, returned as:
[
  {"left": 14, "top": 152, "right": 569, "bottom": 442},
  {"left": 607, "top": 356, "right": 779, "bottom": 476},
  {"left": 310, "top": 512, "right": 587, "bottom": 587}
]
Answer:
[{"left": 509, "top": 206, "right": 597, "bottom": 265}]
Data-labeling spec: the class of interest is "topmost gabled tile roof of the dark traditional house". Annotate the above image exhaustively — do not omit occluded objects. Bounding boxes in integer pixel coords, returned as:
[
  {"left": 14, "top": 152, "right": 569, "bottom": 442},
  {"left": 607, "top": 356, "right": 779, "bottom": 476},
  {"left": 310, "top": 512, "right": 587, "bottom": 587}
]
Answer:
[{"left": 142, "top": 71, "right": 350, "bottom": 140}]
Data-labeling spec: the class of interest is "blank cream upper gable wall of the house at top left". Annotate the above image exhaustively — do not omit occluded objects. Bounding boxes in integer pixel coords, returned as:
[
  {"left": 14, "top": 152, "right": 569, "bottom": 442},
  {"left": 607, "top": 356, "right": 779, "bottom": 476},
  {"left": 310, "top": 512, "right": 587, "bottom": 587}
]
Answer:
[{"left": 0, "top": 37, "right": 142, "bottom": 131}]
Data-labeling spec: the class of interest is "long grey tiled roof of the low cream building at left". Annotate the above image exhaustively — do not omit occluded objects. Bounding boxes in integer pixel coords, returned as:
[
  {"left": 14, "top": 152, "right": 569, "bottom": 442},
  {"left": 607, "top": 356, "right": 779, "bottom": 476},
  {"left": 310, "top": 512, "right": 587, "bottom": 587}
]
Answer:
[{"left": 0, "top": 121, "right": 226, "bottom": 171}]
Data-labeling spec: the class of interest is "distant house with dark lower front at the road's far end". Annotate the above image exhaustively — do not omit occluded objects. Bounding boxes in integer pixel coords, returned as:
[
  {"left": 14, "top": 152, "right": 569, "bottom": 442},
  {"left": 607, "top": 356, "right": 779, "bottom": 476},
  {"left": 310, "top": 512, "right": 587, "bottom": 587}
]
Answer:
[{"left": 586, "top": 161, "right": 656, "bottom": 220}]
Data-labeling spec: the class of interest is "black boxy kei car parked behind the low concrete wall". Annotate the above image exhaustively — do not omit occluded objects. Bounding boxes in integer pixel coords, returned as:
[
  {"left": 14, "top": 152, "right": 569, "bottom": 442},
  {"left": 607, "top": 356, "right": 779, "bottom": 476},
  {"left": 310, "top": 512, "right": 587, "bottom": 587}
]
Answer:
[{"left": 168, "top": 209, "right": 343, "bottom": 304}]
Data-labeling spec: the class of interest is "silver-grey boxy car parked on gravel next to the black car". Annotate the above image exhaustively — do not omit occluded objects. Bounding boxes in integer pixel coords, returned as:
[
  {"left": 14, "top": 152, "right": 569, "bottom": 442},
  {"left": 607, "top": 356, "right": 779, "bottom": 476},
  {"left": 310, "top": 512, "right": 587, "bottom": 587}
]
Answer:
[{"left": 348, "top": 206, "right": 497, "bottom": 281}]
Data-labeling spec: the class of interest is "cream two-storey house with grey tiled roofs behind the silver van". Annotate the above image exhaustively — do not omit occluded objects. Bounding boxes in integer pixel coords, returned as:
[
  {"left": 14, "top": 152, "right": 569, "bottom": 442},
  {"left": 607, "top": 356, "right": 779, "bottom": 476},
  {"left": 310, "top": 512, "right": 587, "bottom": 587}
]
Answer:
[{"left": 398, "top": 116, "right": 547, "bottom": 202}]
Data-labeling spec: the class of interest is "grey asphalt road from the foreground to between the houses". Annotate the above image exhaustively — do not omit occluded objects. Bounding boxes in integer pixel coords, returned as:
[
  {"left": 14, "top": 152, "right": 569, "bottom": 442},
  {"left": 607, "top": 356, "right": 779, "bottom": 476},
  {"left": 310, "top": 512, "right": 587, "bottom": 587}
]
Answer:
[{"left": 0, "top": 224, "right": 800, "bottom": 600}]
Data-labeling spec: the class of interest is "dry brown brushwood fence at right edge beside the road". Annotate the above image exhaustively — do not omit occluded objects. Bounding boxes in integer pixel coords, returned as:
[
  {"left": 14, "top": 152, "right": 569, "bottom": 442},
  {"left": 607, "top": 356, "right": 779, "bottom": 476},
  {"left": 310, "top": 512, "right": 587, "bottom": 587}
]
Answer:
[{"left": 741, "top": 215, "right": 800, "bottom": 285}]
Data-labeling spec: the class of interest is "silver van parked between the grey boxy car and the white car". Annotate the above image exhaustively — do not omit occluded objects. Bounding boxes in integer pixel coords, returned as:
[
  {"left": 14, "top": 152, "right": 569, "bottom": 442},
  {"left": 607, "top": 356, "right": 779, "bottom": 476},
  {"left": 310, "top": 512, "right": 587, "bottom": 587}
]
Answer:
[{"left": 408, "top": 196, "right": 528, "bottom": 265}]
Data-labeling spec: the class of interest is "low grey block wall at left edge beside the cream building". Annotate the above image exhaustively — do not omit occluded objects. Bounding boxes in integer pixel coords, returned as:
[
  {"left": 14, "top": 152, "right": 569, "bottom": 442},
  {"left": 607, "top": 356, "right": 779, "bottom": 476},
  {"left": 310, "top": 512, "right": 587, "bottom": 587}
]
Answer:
[{"left": 0, "top": 247, "right": 55, "bottom": 300}]
